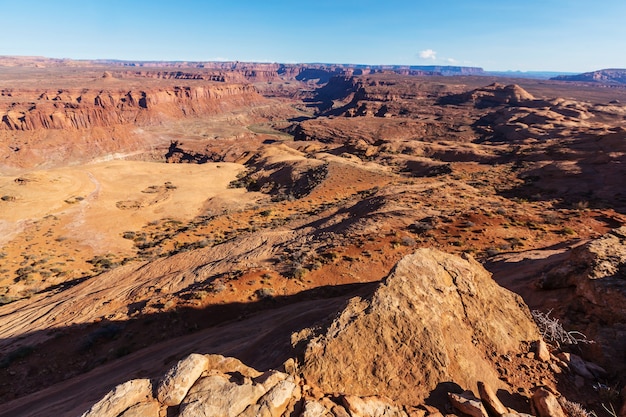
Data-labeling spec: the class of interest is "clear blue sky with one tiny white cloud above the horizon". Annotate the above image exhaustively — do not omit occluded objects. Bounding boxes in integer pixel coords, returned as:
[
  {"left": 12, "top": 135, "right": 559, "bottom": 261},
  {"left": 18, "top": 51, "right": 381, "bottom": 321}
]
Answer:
[{"left": 0, "top": 0, "right": 626, "bottom": 72}]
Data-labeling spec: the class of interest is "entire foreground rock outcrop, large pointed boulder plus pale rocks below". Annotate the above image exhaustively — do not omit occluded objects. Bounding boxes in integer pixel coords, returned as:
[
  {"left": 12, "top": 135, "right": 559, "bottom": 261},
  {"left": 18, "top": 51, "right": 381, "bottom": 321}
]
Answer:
[{"left": 82, "top": 249, "right": 620, "bottom": 417}]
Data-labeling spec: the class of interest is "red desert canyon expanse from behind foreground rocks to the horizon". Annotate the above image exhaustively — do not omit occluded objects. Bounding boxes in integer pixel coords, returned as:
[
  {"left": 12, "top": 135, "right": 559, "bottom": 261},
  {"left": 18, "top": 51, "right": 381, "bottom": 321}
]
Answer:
[{"left": 0, "top": 64, "right": 626, "bottom": 416}]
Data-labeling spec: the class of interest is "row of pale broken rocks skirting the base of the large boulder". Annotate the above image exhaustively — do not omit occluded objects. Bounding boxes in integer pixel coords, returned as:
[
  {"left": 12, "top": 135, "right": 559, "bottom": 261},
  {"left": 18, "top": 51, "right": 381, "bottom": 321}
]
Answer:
[{"left": 81, "top": 353, "right": 596, "bottom": 417}]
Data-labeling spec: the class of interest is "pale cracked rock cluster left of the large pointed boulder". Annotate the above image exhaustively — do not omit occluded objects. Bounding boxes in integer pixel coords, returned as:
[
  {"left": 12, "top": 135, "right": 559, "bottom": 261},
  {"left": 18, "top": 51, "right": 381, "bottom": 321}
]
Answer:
[{"left": 82, "top": 353, "right": 301, "bottom": 417}]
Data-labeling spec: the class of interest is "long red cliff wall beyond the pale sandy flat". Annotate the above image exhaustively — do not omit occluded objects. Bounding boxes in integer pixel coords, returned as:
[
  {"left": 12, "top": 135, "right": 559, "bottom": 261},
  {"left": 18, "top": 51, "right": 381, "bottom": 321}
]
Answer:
[{"left": 0, "top": 83, "right": 262, "bottom": 131}]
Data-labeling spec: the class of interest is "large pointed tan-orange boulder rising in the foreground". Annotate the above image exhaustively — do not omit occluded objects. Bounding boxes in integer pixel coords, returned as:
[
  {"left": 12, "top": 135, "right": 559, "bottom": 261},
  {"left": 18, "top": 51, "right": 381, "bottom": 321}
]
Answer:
[{"left": 302, "top": 249, "right": 540, "bottom": 404}]
